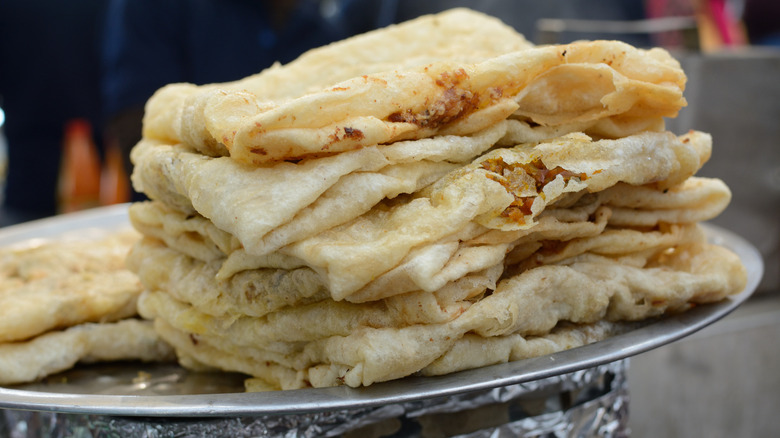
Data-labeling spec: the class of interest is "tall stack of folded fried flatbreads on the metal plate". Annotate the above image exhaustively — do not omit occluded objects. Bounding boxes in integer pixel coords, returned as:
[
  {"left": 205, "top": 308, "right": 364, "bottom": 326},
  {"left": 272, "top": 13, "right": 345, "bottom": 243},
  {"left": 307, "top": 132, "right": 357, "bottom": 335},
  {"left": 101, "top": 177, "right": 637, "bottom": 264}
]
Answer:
[{"left": 128, "top": 9, "right": 746, "bottom": 390}]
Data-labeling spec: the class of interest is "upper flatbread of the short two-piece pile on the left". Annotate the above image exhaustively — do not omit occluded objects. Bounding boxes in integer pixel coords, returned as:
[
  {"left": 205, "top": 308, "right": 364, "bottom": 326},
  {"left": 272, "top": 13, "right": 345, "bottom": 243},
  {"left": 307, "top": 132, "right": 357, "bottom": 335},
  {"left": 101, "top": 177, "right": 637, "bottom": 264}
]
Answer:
[{"left": 0, "top": 230, "right": 142, "bottom": 342}]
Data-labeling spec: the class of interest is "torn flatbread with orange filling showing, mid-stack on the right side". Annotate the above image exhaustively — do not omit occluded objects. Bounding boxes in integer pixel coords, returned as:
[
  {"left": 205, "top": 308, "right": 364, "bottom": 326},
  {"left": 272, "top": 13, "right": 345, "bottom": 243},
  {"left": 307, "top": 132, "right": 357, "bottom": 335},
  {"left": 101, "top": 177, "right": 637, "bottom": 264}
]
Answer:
[{"left": 280, "top": 132, "right": 710, "bottom": 300}]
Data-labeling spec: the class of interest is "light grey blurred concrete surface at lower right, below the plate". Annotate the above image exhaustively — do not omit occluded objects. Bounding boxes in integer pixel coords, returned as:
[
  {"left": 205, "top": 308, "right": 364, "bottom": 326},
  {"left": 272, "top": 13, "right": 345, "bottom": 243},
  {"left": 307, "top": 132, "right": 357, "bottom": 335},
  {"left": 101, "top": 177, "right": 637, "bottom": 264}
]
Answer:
[{"left": 628, "top": 293, "right": 780, "bottom": 438}]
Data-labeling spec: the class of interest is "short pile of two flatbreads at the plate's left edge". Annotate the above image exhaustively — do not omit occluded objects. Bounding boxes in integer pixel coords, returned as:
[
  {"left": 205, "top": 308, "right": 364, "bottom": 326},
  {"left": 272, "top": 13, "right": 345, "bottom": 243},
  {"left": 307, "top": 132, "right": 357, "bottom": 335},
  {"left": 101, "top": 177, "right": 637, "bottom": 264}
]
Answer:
[{"left": 0, "top": 230, "right": 174, "bottom": 385}]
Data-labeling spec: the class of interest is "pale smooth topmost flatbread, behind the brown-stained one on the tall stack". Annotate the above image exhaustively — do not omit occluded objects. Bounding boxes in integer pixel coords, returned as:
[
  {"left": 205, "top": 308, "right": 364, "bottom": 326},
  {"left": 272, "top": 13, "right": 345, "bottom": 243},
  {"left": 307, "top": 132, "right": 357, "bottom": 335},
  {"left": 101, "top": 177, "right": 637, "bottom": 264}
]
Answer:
[{"left": 143, "top": 9, "right": 533, "bottom": 155}]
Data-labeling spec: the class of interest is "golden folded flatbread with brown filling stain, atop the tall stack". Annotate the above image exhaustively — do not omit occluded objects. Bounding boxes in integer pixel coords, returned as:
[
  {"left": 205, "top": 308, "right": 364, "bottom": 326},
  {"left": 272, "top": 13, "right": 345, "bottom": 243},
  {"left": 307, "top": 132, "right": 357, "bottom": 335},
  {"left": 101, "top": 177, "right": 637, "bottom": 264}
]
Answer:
[{"left": 144, "top": 9, "right": 686, "bottom": 165}]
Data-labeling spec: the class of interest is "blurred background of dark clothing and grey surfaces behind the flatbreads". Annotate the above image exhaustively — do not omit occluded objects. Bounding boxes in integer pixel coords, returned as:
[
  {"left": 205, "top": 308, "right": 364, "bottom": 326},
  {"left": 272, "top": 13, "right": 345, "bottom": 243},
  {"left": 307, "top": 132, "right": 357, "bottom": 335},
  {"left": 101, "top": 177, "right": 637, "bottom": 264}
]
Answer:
[{"left": 0, "top": 0, "right": 780, "bottom": 436}]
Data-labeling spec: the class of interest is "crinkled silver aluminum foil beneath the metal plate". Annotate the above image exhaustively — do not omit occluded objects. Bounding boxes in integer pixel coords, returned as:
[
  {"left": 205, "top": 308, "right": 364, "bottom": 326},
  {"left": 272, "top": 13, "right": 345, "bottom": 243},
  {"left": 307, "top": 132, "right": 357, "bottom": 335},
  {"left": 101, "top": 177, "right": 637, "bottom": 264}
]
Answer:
[{"left": 0, "top": 359, "right": 629, "bottom": 438}]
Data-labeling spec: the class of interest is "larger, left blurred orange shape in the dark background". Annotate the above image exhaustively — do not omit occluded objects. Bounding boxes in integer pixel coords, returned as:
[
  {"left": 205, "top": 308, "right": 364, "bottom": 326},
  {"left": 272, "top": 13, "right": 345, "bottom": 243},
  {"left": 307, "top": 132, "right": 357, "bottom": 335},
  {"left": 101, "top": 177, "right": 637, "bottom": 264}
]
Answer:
[{"left": 57, "top": 119, "right": 101, "bottom": 213}]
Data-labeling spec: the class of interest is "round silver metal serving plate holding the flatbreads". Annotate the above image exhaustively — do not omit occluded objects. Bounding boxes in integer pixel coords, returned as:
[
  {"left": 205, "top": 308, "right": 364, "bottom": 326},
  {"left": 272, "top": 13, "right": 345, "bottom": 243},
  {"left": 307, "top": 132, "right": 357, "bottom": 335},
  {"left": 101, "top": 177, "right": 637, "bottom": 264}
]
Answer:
[{"left": 0, "top": 205, "right": 764, "bottom": 417}]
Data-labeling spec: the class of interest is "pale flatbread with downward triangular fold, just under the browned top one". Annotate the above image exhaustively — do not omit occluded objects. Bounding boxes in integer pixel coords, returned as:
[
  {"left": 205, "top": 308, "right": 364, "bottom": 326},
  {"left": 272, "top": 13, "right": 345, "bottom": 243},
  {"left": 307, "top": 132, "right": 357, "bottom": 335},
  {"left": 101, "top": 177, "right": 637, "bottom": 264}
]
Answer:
[{"left": 131, "top": 123, "right": 506, "bottom": 255}]
